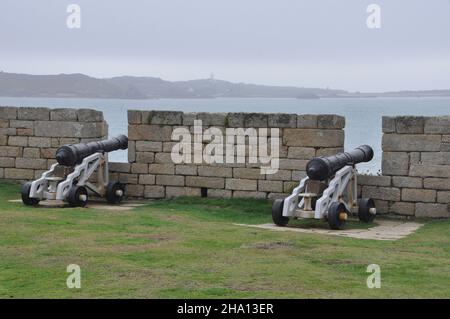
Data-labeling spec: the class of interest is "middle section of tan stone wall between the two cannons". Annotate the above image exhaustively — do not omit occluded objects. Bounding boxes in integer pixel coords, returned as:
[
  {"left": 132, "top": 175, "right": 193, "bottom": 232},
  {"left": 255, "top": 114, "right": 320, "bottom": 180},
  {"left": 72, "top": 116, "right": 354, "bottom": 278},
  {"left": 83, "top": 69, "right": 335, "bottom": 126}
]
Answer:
[{"left": 117, "top": 111, "right": 345, "bottom": 199}]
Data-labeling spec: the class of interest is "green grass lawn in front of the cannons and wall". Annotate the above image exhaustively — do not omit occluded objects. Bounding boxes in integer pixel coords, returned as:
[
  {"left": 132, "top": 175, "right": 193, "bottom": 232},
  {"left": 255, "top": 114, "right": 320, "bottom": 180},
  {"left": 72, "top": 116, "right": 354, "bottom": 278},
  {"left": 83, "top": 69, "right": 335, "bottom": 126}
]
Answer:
[{"left": 0, "top": 182, "right": 450, "bottom": 298}]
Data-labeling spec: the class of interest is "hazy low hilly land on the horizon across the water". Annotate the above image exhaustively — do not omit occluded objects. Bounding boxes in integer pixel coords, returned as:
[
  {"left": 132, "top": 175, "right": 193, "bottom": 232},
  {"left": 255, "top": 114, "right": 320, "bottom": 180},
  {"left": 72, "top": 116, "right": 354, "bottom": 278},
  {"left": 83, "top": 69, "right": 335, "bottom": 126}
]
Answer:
[{"left": 0, "top": 72, "right": 450, "bottom": 99}]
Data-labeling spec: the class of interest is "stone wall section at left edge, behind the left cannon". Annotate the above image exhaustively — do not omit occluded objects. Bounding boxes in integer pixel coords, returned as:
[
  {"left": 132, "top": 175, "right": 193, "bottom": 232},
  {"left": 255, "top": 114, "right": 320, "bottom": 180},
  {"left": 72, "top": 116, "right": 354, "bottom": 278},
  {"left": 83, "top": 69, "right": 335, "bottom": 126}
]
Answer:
[{"left": 0, "top": 107, "right": 108, "bottom": 180}]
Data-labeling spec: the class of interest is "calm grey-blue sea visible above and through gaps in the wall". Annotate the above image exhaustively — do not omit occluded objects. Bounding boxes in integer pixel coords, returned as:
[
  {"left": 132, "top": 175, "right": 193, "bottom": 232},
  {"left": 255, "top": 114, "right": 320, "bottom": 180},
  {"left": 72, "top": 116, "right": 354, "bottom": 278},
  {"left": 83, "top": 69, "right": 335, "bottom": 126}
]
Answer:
[{"left": 0, "top": 97, "right": 450, "bottom": 173}]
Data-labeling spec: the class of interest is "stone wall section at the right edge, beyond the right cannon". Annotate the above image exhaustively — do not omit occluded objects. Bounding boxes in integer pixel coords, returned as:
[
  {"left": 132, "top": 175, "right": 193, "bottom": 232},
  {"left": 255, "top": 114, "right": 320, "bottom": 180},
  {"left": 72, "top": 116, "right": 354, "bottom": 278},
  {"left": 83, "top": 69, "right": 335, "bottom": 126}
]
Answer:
[{"left": 359, "top": 116, "right": 450, "bottom": 217}]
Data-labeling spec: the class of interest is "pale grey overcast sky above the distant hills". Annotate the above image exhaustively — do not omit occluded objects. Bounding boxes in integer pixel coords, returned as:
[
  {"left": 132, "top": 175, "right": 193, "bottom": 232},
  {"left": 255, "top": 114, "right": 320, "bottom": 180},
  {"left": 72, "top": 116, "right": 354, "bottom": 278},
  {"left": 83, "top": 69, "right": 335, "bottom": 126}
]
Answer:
[{"left": 0, "top": 0, "right": 450, "bottom": 91}]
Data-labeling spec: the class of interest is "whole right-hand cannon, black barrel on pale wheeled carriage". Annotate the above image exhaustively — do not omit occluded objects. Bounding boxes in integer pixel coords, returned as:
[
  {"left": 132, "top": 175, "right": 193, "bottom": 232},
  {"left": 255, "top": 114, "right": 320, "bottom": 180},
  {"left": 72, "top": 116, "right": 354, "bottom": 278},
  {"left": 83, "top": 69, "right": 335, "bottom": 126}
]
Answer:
[{"left": 272, "top": 145, "right": 376, "bottom": 229}]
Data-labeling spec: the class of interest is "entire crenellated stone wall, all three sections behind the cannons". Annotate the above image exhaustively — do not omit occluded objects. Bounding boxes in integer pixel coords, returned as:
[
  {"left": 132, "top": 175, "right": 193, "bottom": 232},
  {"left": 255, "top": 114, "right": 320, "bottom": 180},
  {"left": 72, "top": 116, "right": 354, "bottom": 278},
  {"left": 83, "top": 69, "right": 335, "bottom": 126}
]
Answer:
[{"left": 0, "top": 107, "right": 450, "bottom": 217}]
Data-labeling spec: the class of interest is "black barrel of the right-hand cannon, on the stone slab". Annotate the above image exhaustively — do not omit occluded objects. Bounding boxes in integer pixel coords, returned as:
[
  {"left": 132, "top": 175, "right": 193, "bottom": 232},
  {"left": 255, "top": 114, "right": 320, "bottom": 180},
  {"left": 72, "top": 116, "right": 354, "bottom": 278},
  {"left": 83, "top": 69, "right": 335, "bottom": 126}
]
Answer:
[{"left": 306, "top": 145, "right": 373, "bottom": 181}]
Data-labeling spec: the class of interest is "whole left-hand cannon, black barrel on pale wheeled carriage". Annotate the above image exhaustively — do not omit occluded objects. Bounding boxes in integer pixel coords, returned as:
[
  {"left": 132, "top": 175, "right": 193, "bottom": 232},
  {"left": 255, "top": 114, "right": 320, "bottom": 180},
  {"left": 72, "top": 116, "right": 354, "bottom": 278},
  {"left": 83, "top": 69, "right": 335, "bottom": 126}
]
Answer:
[{"left": 22, "top": 135, "right": 128, "bottom": 207}]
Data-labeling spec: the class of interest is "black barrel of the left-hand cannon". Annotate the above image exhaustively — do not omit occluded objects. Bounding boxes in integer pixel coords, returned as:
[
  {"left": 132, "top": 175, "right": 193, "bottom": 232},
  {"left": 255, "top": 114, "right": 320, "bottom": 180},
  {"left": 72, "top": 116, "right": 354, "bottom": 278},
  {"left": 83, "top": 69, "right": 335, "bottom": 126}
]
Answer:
[{"left": 56, "top": 135, "right": 128, "bottom": 166}]
